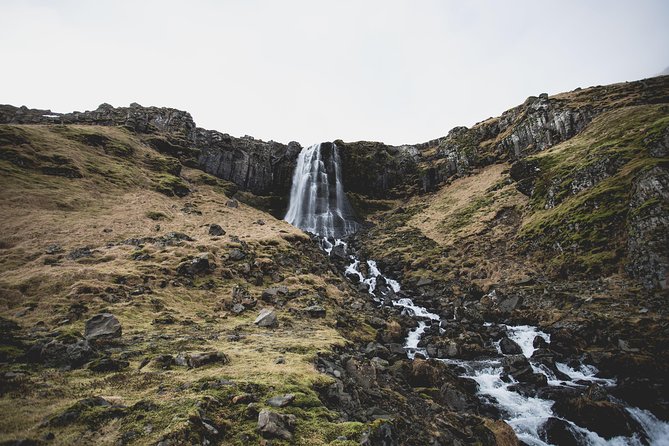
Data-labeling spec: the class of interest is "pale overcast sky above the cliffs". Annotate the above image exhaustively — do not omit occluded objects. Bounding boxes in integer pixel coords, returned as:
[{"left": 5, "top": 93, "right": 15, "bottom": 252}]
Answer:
[{"left": 0, "top": 0, "right": 669, "bottom": 144}]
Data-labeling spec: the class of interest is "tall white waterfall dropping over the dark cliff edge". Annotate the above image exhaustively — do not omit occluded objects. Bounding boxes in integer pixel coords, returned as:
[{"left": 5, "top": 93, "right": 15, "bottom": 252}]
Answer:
[{"left": 284, "top": 143, "right": 359, "bottom": 238}]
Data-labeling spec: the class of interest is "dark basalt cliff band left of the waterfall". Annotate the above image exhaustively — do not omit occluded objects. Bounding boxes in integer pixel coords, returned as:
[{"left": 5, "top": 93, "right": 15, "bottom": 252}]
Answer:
[{"left": 0, "top": 103, "right": 301, "bottom": 196}]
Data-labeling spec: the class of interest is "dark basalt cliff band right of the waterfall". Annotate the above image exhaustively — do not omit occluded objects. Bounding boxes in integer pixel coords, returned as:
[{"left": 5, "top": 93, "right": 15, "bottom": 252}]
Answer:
[{"left": 345, "top": 76, "right": 669, "bottom": 197}]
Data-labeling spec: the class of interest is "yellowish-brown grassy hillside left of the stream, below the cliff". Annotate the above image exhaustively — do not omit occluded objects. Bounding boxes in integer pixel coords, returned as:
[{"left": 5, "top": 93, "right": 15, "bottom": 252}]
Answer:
[{"left": 0, "top": 125, "right": 376, "bottom": 445}]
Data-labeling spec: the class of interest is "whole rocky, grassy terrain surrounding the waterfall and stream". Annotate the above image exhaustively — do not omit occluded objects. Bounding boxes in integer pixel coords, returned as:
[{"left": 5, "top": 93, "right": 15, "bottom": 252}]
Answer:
[{"left": 0, "top": 76, "right": 669, "bottom": 446}]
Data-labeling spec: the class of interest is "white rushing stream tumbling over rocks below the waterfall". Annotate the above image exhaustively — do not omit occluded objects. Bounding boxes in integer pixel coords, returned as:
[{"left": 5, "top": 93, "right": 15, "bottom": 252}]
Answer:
[{"left": 340, "top": 240, "right": 669, "bottom": 446}]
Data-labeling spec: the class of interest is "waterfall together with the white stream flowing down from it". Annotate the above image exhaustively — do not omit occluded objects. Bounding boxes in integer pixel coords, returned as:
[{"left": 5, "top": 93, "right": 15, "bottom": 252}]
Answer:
[{"left": 285, "top": 143, "right": 669, "bottom": 446}]
